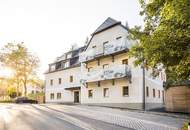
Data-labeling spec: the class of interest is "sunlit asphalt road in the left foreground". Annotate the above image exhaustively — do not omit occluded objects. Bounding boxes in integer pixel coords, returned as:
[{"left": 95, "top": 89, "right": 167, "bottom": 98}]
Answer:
[{"left": 0, "top": 104, "right": 132, "bottom": 130}]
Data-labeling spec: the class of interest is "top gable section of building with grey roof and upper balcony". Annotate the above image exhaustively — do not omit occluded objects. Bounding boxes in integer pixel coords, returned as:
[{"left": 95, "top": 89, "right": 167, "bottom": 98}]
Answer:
[{"left": 80, "top": 17, "right": 131, "bottom": 62}]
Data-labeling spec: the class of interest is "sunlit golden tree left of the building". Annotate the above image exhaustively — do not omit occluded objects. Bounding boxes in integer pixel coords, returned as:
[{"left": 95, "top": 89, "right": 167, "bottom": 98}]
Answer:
[{"left": 0, "top": 43, "right": 39, "bottom": 96}]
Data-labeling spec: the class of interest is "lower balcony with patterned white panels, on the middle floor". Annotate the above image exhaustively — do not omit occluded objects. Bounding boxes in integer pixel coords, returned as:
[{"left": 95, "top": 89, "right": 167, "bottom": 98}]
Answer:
[{"left": 81, "top": 65, "right": 131, "bottom": 83}]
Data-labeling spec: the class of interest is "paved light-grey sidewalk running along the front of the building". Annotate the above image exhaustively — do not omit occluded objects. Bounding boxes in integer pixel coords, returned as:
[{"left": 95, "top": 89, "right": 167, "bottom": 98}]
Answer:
[{"left": 41, "top": 104, "right": 187, "bottom": 130}]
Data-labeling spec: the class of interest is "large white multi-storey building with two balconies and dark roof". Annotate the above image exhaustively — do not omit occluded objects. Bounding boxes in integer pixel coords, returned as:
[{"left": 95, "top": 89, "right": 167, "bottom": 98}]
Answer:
[{"left": 46, "top": 18, "right": 165, "bottom": 109}]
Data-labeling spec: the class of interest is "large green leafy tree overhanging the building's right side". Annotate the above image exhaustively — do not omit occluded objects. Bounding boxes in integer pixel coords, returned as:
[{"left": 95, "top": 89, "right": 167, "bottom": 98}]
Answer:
[{"left": 130, "top": 0, "right": 190, "bottom": 82}]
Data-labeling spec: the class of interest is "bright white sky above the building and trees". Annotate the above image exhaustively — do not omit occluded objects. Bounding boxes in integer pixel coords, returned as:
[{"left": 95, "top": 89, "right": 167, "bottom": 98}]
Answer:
[{"left": 0, "top": 0, "right": 143, "bottom": 76}]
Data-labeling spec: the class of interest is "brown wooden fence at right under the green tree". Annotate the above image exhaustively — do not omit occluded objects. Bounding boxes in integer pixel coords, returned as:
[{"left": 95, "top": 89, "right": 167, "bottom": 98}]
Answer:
[{"left": 165, "top": 86, "right": 190, "bottom": 113}]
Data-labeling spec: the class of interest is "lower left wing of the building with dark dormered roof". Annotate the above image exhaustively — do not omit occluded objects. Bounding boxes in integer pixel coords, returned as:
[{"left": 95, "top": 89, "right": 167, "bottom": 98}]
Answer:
[{"left": 45, "top": 47, "right": 85, "bottom": 103}]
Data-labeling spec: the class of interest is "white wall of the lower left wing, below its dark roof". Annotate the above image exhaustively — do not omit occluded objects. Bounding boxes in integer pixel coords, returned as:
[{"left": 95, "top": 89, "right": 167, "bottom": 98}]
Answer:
[{"left": 45, "top": 67, "right": 80, "bottom": 103}]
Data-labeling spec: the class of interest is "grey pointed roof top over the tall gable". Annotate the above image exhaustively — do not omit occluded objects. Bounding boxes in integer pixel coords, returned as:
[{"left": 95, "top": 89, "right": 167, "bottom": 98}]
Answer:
[{"left": 92, "top": 17, "right": 121, "bottom": 35}]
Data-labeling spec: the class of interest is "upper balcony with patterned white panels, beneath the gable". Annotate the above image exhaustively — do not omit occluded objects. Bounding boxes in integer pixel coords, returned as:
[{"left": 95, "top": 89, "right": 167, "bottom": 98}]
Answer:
[{"left": 79, "top": 39, "right": 130, "bottom": 62}]
